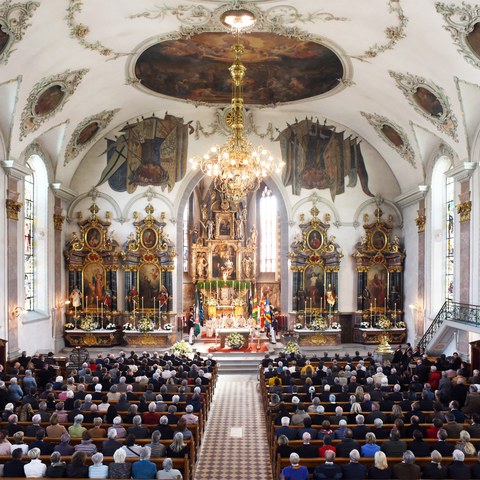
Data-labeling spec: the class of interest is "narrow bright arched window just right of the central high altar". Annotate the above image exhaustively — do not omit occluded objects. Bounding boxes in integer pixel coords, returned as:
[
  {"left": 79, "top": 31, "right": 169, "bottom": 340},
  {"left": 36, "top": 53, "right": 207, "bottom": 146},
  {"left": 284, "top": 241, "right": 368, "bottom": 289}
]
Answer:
[{"left": 259, "top": 186, "right": 278, "bottom": 273}]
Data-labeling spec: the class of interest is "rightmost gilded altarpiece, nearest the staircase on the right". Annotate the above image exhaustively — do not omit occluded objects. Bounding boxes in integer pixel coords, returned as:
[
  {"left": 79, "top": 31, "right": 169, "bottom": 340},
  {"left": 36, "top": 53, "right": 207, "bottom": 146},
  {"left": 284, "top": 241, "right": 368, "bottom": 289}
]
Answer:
[{"left": 353, "top": 208, "right": 406, "bottom": 343}]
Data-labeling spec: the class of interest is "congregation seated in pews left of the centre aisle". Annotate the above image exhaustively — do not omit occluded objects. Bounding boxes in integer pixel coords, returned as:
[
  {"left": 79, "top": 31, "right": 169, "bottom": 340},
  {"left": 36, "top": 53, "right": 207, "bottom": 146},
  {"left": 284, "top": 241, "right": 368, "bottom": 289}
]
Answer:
[{"left": 0, "top": 351, "right": 216, "bottom": 480}]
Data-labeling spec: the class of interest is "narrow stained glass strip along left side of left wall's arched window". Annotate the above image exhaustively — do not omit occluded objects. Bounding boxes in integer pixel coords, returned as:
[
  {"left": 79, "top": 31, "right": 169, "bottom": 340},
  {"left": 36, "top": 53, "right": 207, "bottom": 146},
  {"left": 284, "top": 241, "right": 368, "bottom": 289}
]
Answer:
[{"left": 23, "top": 169, "right": 35, "bottom": 311}]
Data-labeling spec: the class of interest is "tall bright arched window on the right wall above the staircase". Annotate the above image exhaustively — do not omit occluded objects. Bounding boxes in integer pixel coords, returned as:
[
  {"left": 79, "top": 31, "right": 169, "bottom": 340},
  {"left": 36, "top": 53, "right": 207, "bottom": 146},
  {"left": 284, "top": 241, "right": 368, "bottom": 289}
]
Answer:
[{"left": 430, "top": 157, "right": 455, "bottom": 314}]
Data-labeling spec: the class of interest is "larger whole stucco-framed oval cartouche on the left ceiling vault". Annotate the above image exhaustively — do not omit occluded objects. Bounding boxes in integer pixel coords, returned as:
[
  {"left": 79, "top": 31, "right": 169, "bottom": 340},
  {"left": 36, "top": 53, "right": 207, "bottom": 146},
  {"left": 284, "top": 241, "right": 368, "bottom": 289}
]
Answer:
[{"left": 20, "top": 69, "right": 88, "bottom": 140}]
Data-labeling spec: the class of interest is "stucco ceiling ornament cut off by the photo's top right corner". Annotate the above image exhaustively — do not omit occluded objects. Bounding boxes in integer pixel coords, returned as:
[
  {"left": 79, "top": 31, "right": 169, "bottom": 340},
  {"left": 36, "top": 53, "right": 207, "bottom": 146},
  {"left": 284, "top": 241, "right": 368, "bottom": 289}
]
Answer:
[{"left": 435, "top": 2, "right": 480, "bottom": 68}]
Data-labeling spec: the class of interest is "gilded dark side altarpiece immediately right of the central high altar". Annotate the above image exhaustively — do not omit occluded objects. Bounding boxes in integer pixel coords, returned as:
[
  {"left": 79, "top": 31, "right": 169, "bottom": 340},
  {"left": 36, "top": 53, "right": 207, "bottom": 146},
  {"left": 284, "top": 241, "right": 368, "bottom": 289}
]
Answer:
[{"left": 289, "top": 206, "right": 343, "bottom": 318}]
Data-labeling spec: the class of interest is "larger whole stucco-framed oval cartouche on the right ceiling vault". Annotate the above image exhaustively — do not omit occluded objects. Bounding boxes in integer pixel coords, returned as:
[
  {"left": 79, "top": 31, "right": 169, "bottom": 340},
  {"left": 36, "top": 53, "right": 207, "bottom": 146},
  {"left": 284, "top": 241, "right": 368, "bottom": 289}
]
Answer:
[{"left": 390, "top": 70, "right": 458, "bottom": 142}]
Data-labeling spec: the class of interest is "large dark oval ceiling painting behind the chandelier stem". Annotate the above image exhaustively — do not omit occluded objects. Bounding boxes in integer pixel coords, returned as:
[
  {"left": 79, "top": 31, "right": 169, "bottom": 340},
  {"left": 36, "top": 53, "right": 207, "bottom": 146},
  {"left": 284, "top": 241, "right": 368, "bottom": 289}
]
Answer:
[{"left": 135, "top": 32, "right": 344, "bottom": 105}]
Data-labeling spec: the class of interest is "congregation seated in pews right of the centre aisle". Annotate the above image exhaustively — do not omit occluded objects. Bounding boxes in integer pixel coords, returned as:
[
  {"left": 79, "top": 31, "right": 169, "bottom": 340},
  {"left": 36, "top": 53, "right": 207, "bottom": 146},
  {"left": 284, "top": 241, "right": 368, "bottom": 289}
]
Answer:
[{"left": 260, "top": 345, "right": 480, "bottom": 480}]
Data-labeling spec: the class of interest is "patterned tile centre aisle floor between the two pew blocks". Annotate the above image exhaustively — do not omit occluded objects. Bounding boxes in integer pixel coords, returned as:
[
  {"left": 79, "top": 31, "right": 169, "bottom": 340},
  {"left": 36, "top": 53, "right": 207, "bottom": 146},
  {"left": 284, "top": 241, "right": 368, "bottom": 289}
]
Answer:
[{"left": 194, "top": 374, "right": 272, "bottom": 480}]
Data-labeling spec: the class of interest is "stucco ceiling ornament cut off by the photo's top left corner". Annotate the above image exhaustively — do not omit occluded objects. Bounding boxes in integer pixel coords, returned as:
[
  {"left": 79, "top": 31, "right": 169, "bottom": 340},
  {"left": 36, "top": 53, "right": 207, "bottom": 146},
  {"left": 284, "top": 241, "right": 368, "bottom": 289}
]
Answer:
[{"left": 0, "top": 0, "right": 40, "bottom": 64}]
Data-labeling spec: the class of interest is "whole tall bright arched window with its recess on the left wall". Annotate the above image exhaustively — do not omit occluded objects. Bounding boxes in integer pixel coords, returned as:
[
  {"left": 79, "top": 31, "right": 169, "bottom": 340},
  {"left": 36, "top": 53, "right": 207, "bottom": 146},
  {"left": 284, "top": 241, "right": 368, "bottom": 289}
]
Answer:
[{"left": 23, "top": 155, "right": 48, "bottom": 312}]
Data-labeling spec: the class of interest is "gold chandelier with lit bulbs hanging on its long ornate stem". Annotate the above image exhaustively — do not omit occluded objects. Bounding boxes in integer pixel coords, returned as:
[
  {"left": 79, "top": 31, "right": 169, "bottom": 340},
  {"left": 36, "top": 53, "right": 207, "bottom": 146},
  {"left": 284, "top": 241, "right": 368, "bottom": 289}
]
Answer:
[{"left": 190, "top": 9, "right": 284, "bottom": 203}]
